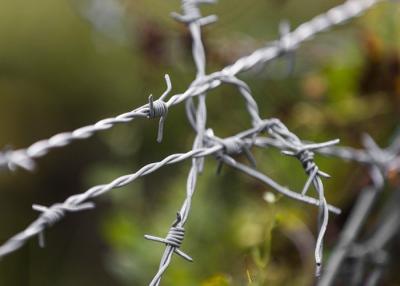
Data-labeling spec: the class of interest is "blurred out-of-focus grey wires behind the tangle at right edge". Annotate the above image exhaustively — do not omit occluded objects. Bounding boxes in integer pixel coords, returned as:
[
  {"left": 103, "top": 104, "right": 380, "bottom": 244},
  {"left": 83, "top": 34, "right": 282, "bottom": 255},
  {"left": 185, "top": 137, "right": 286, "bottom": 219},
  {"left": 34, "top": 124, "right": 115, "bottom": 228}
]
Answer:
[{"left": 254, "top": 131, "right": 400, "bottom": 286}]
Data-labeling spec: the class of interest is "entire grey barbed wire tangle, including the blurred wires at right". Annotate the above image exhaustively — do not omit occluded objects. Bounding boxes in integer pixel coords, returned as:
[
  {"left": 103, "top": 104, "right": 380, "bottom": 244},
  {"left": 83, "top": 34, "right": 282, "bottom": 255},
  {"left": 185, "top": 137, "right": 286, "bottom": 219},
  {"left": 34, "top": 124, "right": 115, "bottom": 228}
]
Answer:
[{"left": 0, "top": 0, "right": 400, "bottom": 286}]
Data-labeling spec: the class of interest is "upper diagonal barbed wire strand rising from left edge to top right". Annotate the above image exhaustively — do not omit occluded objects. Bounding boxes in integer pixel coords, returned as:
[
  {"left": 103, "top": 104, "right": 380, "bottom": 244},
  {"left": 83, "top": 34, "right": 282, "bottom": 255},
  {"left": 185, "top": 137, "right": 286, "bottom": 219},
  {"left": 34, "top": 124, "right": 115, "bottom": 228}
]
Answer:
[{"left": 0, "top": 0, "right": 383, "bottom": 170}]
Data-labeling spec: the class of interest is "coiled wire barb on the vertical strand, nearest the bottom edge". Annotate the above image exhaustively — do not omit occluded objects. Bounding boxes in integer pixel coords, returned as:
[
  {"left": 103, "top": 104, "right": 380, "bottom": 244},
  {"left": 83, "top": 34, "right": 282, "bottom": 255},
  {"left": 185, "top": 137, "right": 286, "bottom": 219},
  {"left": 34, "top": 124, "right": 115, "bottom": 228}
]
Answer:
[{"left": 144, "top": 213, "right": 193, "bottom": 262}]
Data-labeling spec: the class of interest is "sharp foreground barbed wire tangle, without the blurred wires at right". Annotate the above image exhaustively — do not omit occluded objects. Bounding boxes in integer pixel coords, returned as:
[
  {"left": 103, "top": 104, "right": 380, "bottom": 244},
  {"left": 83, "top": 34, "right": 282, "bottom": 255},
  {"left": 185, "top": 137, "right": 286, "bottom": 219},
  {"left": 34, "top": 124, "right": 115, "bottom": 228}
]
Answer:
[{"left": 0, "top": 0, "right": 390, "bottom": 285}]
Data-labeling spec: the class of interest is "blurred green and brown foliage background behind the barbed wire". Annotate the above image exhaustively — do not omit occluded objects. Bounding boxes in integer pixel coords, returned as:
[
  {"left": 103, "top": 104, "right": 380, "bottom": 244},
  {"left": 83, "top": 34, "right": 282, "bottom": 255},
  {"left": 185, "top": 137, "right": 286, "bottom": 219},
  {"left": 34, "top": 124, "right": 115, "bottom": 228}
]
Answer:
[{"left": 0, "top": 0, "right": 400, "bottom": 286}]
